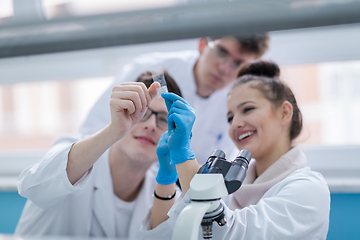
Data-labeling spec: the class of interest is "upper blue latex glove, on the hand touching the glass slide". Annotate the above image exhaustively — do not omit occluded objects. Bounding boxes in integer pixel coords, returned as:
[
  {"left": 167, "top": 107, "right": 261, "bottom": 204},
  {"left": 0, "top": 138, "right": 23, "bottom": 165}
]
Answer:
[{"left": 161, "top": 93, "right": 195, "bottom": 164}]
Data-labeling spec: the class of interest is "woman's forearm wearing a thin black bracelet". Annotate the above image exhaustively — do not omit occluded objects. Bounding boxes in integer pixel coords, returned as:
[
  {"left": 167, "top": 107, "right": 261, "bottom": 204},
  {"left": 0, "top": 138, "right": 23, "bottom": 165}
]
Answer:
[{"left": 151, "top": 183, "right": 175, "bottom": 229}]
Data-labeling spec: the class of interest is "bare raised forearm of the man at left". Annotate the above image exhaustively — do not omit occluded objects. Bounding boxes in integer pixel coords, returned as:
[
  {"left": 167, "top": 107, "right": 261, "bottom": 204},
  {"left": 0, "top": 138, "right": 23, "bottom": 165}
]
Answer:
[{"left": 66, "top": 125, "right": 121, "bottom": 184}]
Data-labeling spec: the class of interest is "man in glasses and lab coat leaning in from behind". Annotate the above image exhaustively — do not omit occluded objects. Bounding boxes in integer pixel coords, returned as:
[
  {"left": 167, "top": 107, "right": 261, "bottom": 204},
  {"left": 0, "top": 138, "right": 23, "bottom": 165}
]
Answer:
[{"left": 81, "top": 34, "right": 269, "bottom": 164}]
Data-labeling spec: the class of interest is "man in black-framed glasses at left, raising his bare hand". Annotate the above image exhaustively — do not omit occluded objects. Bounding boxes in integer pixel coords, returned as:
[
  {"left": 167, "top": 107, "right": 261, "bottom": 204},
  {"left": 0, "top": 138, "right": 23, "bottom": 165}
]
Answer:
[{"left": 15, "top": 72, "right": 181, "bottom": 239}]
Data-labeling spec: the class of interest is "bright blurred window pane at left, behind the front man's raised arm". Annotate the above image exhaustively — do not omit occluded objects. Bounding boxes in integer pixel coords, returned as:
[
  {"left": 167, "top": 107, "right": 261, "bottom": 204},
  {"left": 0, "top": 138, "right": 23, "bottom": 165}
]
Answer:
[{"left": 0, "top": 78, "right": 112, "bottom": 150}]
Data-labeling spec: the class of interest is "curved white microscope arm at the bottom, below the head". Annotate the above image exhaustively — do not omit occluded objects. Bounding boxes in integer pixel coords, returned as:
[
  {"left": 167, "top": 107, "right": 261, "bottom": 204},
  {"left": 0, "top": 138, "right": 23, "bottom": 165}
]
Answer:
[{"left": 172, "top": 202, "right": 212, "bottom": 240}]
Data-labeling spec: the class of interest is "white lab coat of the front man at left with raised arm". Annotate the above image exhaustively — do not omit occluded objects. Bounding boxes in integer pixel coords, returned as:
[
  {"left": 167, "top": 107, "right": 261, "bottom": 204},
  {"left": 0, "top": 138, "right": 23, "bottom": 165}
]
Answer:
[{"left": 15, "top": 138, "right": 157, "bottom": 239}]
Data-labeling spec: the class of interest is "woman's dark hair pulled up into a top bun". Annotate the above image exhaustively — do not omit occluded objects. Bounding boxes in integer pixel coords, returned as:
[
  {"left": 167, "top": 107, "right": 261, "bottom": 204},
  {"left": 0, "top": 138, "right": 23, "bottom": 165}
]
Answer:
[{"left": 232, "top": 60, "right": 303, "bottom": 140}]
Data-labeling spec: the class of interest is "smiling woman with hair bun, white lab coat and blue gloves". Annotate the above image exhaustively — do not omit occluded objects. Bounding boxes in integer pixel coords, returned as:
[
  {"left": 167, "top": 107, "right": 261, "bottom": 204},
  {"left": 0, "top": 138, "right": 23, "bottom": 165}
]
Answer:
[{"left": 142, "top": 61, "right": 330, "bottom": 240}]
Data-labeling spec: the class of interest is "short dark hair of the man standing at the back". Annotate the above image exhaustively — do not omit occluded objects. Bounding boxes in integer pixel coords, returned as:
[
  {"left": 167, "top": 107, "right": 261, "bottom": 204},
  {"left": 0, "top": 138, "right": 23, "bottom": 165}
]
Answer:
[{"left": 236, "top": 33, "right": 270, "bottom": 58}]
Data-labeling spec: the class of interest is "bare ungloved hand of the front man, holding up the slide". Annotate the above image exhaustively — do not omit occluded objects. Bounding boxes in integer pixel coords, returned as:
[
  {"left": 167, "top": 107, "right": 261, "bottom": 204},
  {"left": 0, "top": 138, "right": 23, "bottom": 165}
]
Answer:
[{"left": 110, "top": 82, "right": 152, "bottom": 116}]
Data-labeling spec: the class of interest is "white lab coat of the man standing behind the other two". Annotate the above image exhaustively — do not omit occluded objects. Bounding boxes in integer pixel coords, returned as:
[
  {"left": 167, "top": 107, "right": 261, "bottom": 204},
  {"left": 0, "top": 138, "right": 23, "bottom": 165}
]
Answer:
[{"left": 81, "top": 51, "right": 236, "bottom": 164}]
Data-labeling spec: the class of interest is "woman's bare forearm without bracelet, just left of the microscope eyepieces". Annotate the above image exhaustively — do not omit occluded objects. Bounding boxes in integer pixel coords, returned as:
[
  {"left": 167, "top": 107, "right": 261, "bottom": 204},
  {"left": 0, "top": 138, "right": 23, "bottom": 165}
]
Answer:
[{"left": 176, "top": 159, "right": 200, "bottom": 195}]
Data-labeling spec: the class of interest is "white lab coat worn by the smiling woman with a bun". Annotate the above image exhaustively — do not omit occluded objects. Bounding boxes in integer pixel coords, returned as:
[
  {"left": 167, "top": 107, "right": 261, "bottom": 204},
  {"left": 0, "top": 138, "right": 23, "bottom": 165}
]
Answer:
[{"left": 142, "top": 167, "right": 330, "bottom": 240}]
